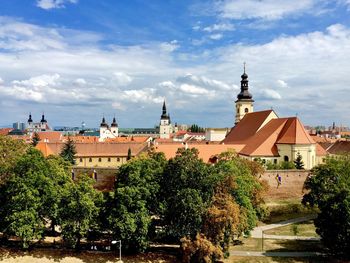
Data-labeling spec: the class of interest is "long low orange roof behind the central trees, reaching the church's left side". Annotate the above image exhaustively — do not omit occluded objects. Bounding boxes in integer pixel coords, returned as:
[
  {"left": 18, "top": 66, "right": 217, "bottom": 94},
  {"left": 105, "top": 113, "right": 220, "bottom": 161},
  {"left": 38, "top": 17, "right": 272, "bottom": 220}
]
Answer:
[{"left": 155, "top": 143, "right": 242, "bottom": 162}]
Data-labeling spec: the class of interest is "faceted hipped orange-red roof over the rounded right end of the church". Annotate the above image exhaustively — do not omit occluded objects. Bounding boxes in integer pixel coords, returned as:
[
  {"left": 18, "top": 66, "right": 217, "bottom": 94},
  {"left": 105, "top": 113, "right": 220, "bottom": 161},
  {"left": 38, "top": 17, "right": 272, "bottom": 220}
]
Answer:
[{"left": 276, "top": 117, "right": 315, "bottom": 144}]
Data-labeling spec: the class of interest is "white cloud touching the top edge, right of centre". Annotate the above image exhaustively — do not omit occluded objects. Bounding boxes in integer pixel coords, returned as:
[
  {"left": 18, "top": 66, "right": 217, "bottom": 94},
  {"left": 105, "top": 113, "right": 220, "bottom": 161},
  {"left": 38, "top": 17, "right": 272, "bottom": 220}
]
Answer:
[{"left": 216, "top": 0, "right": 316, "bottom": 20}]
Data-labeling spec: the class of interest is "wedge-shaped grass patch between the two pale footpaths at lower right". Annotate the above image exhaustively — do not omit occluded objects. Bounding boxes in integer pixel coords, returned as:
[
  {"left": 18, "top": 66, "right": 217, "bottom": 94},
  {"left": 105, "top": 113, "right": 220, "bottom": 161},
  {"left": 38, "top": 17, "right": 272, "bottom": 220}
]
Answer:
[{"left": 264, "top": 220, "right": 318, "bottom": 237}]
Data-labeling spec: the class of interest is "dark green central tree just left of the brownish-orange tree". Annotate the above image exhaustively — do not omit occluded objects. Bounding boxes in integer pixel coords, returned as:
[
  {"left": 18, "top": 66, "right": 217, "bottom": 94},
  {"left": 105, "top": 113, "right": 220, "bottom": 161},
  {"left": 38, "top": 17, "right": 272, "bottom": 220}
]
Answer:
[{"left": 161, "top": 148, "right": 214, "bottom": 240}]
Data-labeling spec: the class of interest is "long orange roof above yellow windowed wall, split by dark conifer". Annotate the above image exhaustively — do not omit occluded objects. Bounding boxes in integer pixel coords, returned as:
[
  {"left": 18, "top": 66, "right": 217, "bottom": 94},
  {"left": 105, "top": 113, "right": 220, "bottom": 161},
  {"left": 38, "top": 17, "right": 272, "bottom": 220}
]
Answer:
[{"left": 36, "top": 142, "right": 147, "bottom": 157}]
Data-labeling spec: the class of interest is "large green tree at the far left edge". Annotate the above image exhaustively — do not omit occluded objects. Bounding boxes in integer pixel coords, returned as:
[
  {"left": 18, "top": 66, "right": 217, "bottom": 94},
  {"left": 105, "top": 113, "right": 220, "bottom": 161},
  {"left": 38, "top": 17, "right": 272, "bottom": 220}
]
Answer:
[{"left": 0, "top": 148, "right": 67, "bottom": 248}]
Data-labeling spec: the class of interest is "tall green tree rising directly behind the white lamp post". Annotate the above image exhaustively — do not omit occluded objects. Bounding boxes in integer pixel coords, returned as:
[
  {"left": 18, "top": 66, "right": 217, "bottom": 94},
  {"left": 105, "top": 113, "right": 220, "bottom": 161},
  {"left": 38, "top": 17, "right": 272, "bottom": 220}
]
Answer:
[{"left": 108, "top": 152, "right": 166, "bottom": 252}]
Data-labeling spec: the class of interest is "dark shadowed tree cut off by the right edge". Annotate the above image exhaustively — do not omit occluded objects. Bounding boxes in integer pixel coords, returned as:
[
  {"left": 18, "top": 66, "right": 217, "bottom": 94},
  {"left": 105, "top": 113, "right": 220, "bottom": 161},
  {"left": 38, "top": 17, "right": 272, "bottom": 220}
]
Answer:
[{"left": 303, "top": 155, "right": 350, "bottom": 258}]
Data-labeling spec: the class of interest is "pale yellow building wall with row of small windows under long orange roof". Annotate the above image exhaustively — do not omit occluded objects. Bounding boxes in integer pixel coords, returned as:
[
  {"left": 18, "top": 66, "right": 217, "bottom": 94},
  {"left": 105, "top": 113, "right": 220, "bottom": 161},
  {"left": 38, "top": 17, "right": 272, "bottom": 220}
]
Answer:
[{"left": 75, "top": 156, "right": 127, "bottom": 168}]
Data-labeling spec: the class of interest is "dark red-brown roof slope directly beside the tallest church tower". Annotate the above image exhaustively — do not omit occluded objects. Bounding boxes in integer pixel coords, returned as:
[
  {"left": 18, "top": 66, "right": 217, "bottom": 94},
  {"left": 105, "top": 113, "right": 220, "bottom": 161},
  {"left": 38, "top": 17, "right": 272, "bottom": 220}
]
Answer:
[{"left": 222, "top": 110, "right": 273, "bottom": 144}]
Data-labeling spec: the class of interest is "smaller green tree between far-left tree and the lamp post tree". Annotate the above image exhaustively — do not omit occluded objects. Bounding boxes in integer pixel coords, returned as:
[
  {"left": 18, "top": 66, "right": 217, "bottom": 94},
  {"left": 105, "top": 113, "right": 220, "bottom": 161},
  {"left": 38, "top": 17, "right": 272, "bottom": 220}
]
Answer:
[{"left": 58, "top": 175, "right": 102, "bottom": 249}]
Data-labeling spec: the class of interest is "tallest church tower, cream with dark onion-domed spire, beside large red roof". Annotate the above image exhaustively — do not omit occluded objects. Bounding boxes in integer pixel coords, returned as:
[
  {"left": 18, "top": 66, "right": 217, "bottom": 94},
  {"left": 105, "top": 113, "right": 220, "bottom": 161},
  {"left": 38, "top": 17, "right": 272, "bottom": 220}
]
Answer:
[{"left": 235, "top": 63, "right": 254, "bottom": 124}]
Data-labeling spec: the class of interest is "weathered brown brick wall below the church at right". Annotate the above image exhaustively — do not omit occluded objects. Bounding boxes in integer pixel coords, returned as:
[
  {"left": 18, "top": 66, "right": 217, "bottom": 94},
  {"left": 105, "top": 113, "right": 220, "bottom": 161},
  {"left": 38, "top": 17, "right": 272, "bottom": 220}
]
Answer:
[{"left": 260, "top": 170, "right": 309, "bottom": 199}]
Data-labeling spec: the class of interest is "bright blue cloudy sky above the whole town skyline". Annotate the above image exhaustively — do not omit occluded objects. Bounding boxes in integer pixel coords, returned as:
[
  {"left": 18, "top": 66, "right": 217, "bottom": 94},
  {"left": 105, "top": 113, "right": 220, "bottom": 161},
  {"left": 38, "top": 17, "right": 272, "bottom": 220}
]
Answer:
[{"left": 0, "top": 0, "right": 350, "bottom": 128}]
